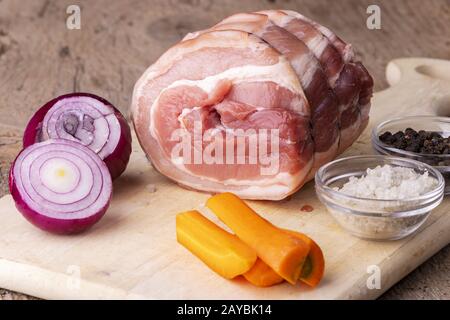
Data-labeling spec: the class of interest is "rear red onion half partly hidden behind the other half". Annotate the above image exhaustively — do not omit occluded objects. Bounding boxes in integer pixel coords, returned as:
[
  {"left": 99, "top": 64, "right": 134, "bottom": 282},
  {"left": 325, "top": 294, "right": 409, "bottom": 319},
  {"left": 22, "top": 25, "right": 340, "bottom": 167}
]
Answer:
[{"left": 23, "top": 93, "right": 131, "bottom": 179}]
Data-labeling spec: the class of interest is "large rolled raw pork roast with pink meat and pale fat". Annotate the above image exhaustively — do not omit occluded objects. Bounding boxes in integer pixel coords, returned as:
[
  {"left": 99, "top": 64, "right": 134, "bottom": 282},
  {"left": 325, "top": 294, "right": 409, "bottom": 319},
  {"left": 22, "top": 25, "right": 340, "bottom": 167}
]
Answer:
[{"left": 131, "top": 10, "right": 373, "bottom": 200}]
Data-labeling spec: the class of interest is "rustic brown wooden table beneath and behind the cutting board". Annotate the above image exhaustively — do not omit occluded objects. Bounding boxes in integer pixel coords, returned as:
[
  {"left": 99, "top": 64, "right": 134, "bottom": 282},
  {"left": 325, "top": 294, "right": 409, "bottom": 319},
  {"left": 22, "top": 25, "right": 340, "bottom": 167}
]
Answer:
[{"left": 0, "top": 0, "right": 450, "bottom": 299}]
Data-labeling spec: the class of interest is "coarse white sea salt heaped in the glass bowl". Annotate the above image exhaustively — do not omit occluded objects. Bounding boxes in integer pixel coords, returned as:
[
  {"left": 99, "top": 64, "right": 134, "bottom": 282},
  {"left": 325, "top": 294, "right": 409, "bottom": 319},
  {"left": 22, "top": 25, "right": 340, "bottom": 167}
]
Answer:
[{"left": 333, "top": 165, "right": 438, "bottom": 200}]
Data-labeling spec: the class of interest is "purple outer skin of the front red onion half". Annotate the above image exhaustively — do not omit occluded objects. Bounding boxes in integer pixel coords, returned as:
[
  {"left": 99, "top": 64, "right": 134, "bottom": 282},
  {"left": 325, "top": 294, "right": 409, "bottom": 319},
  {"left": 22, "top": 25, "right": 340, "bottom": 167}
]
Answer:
[{"left": 9, "top": 153, "right": 111, "bottom": 235}]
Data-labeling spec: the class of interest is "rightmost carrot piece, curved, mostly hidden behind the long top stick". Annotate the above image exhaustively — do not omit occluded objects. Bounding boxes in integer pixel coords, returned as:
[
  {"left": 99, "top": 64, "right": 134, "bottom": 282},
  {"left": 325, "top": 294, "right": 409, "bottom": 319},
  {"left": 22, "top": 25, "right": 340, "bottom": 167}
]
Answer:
[{"left": 284, "top": 230, "right": 325, "bottom": 287}]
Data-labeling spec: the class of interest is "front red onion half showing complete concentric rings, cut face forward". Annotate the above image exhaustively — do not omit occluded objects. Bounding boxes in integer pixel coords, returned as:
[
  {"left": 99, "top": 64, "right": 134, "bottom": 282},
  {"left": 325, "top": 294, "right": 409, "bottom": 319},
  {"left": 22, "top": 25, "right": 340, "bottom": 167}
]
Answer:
[{"left": 9, "top": 139, "right": 112, "bottom": 234}]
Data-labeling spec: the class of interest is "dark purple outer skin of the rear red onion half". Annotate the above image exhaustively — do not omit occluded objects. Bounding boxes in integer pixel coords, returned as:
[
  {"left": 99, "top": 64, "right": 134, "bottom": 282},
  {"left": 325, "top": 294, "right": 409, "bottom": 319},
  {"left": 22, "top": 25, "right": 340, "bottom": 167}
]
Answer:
[{"left": 23, "top": 92, "right": 131, "bottom": 180}]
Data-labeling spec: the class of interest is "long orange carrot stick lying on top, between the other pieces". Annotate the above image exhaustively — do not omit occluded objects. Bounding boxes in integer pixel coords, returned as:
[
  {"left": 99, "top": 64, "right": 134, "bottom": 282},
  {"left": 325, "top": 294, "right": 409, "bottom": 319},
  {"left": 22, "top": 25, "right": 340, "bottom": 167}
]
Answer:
[{"left": 206, "top": 193, "right": 309, "bottom": 284}]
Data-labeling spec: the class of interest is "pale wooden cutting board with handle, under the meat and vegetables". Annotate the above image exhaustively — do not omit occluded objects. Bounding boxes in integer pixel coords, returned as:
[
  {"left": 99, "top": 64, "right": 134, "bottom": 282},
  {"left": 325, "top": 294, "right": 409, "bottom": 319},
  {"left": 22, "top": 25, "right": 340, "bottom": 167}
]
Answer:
[{"left": 0, "top": 58, "right": 450, "bottom": 299}]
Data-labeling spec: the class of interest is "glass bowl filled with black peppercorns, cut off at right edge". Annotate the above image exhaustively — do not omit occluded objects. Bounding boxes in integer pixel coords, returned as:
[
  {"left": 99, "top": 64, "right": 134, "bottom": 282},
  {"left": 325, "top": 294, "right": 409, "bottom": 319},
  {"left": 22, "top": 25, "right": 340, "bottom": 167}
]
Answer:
[{"left": 372, "top": 116, "right": 450, "bottom": 195}]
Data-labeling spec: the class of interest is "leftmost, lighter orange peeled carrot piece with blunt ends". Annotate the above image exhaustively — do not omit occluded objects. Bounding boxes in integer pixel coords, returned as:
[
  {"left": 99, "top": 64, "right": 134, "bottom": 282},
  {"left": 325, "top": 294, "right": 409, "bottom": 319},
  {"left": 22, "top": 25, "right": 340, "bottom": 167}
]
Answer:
[{"left": 176, "top": 211, "right": 257, "bottom": 279}]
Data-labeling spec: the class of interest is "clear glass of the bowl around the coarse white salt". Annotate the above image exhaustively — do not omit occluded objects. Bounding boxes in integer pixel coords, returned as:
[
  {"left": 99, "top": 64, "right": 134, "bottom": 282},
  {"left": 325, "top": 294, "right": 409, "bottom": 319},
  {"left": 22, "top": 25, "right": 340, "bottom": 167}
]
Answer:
[{"left": 315, "top": 155, "right": 445, "bottom": 240}]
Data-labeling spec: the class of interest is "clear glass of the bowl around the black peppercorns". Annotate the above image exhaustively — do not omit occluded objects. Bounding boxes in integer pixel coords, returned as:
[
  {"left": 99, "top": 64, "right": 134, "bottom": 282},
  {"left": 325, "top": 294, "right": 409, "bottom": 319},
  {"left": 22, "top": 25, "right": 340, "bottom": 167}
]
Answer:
[{"left": 372, "top": 116, "right": 450, "bottom": 195}]
